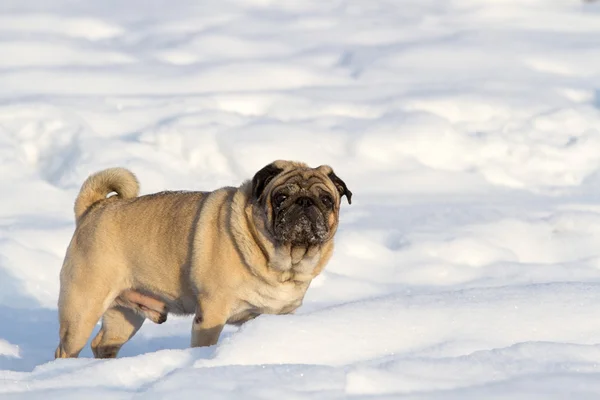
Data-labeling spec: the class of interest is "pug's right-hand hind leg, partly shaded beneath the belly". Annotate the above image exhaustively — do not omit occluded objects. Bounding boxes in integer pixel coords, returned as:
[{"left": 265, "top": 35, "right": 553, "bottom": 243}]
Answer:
[{"left": 92, "top": 306, "right": 145, "bottom": 358}]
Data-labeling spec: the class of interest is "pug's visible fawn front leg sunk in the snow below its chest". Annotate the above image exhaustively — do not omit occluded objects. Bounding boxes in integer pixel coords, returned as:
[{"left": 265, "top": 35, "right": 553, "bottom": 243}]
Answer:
[{"left": 192, "top": 298, "right": 230, "bottom": 347}]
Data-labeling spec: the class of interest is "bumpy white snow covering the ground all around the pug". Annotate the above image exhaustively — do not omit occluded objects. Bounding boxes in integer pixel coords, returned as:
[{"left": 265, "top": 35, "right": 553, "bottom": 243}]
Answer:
[{"left": 0, "top": 0, "right": 600, "bottom": 400}]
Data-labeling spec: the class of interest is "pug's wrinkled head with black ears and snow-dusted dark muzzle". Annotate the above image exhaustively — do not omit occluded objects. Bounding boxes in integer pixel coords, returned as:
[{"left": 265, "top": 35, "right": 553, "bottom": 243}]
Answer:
[{"left": 252, "top": 160, "right": 352, "bottom": 246}]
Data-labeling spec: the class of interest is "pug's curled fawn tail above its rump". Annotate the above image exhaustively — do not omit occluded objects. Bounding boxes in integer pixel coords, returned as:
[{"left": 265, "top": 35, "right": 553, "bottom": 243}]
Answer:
[{"left": 75, "top": 167, "right": 140, "bottom": 221}]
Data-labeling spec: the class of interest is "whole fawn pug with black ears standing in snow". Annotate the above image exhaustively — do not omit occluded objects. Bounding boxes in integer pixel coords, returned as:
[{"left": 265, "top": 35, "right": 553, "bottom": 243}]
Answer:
[{"left": 55, "top": 160, "right": 352, "bottom": 358}]
